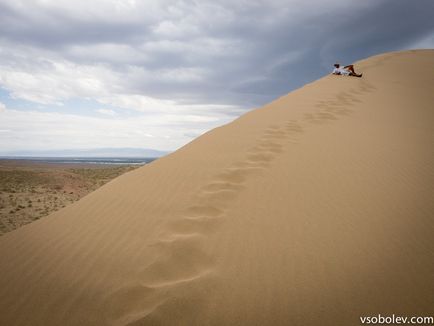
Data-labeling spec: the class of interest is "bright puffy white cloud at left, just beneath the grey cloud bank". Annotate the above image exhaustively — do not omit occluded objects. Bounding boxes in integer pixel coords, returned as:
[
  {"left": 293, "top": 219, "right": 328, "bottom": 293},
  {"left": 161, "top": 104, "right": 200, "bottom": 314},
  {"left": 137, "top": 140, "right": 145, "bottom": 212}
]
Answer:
[{"left": 0, "top": 44, "right": 215, "bottom": 112}]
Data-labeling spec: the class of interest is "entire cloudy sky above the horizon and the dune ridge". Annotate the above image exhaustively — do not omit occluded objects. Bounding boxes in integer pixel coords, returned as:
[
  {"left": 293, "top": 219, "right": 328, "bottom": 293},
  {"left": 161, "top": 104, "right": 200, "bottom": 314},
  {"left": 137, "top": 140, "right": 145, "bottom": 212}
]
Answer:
[{"left": 0, "top": 0, "right": 434, "bottom": 155}]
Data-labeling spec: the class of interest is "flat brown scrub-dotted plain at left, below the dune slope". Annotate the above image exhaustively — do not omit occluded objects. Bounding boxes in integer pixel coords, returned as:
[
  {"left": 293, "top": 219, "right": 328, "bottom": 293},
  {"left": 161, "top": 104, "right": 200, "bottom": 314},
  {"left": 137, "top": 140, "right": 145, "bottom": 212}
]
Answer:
[{"left": 0, "top": 159, "right": 138, "bottom": 236}]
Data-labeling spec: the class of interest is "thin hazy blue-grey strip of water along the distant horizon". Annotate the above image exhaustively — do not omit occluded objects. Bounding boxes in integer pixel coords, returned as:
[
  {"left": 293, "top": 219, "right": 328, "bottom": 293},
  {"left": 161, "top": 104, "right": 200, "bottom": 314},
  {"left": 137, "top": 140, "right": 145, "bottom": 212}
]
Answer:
[{"left": 0, "top": 156, "right": 157, "bottom": 165}]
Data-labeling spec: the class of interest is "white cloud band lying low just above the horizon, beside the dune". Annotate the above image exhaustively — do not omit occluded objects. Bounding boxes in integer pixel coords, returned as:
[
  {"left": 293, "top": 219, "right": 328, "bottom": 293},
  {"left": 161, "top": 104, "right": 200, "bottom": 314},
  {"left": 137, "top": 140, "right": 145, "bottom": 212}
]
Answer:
[{"left": 0, "top": 109, "right": 230, "bottom": 154}]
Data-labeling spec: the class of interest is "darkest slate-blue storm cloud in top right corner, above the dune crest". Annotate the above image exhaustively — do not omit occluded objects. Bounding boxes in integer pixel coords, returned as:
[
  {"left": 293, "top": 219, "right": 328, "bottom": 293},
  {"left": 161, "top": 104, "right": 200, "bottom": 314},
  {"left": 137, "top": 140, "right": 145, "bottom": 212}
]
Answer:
[{"left": 322, "top": 0, "right": 434, "bottom": 65}]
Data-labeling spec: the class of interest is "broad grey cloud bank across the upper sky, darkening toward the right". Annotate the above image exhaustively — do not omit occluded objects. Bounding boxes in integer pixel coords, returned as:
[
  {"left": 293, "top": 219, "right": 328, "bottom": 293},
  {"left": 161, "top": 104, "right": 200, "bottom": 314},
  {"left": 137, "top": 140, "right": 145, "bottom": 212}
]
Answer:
[{"left": 0, "top": 0, "right": 434, "bottom": 108}]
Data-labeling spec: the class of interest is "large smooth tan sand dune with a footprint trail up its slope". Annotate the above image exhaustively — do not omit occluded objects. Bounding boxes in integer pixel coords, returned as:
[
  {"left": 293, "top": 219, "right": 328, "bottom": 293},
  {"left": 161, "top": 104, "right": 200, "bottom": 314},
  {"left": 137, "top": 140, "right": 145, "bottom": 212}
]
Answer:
[{"left": 0, "top": 50, "right": 434, "bottom": 326}]
